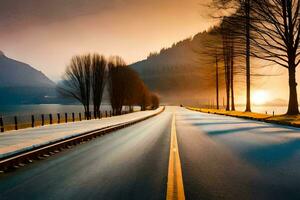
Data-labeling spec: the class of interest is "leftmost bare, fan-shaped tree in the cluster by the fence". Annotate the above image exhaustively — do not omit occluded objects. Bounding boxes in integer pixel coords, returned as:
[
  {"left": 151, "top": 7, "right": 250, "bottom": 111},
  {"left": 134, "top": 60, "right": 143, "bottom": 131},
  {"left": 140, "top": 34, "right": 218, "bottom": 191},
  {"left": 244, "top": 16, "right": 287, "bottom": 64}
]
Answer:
[{"left": 58, "top": 55, "right": 91, "bottom": 118}]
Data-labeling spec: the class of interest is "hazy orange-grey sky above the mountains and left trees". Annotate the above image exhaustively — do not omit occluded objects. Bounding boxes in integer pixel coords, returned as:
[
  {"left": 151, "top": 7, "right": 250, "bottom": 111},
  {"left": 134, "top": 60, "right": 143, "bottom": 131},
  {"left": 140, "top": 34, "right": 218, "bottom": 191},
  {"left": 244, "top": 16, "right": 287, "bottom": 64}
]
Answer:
[{"left": 0, "top": 0, "right": 211, "bottom": 80}]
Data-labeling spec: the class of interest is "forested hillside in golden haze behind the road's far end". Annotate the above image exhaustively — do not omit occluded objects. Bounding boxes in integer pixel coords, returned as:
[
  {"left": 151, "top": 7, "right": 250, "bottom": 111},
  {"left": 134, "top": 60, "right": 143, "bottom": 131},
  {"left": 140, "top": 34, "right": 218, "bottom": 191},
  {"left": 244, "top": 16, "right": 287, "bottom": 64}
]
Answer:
[{"left": 131, "top": 31, "right": 215, "bottom": 104}]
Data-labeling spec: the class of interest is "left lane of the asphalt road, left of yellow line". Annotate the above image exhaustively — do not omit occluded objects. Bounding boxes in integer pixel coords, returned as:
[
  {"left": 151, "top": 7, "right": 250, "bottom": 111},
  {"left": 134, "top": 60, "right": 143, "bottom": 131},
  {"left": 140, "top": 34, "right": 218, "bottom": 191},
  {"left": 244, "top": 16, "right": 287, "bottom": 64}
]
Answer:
[{"left": 0, "top": 111, "right": 172, "bottom": 200}]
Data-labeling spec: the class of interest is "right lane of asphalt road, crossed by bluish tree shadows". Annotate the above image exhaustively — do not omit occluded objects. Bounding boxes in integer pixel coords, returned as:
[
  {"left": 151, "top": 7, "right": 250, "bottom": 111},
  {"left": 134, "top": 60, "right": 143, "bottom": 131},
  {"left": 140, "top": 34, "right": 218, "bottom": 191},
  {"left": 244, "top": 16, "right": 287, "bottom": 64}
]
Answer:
[{"left": 176, "top": 109, "right": 300, "bottom": 200}]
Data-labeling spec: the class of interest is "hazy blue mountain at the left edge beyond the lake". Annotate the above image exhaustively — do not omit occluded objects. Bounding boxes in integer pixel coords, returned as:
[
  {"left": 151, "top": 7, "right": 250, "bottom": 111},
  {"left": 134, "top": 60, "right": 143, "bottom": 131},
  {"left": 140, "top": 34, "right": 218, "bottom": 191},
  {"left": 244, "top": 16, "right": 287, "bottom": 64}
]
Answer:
[{"left": 0, "top": 51, "right": 57, "bottom": 104}]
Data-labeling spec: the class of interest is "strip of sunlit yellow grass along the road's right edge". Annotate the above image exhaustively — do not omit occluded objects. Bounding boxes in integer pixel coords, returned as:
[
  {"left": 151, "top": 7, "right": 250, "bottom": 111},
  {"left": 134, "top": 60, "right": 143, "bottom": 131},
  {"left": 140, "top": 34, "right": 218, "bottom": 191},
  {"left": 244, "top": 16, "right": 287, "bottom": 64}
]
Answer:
[{"left": 186, "top": 107, "right": 300, "bottom": 127}]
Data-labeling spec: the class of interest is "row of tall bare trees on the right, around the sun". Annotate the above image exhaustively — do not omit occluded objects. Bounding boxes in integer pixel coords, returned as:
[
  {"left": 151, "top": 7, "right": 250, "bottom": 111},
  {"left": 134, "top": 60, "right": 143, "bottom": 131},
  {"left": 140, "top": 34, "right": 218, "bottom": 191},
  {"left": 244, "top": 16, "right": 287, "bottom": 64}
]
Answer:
[{"left": 204, "top": 0, "right": 300, "bottom": 115}]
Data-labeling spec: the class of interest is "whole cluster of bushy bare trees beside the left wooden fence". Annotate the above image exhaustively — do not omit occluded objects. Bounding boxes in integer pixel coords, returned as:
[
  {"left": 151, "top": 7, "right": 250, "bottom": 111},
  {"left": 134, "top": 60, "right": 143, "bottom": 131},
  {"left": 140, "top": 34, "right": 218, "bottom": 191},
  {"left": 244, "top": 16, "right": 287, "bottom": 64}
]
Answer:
[{"left": 57, "top": 53, "right": 159, "bottom": 118}]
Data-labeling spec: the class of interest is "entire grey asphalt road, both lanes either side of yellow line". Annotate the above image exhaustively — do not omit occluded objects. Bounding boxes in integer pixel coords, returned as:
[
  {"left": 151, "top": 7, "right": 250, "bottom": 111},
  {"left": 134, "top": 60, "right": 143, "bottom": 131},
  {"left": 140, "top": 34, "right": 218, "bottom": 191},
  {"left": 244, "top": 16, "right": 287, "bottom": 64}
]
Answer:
[{"left": 0, "top": 107, "right": 300, "bottom": 200}]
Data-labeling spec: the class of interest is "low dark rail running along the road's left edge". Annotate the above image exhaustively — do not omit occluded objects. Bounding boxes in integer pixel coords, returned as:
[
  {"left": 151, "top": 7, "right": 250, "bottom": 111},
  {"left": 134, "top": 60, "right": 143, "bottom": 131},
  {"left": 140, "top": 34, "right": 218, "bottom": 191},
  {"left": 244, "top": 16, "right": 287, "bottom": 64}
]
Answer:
[{"left": 0, "top": 107, "right": 165, "bottom": 171}]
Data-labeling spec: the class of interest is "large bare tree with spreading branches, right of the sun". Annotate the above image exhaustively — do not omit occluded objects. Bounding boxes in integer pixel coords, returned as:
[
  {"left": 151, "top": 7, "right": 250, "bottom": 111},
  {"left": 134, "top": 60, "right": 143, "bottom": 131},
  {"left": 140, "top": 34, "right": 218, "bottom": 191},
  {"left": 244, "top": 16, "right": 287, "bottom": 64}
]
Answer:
[{"left": 252, "top": 0, "right": 300, "bottom": 115}]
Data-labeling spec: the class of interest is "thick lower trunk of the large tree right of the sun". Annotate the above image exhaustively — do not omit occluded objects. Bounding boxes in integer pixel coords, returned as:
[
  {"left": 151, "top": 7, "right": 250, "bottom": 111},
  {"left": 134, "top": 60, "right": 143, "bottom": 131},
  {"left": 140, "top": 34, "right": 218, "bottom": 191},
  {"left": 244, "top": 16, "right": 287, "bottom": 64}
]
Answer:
[{"left": 287, "top": 64, "right": 299, "bottom": 115}]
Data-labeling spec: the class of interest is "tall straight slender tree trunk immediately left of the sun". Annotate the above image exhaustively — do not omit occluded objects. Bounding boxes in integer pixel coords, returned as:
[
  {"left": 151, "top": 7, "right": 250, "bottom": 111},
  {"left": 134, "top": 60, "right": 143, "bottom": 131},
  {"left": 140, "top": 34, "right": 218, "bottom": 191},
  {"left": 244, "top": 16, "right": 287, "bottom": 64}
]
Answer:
[{"left": 245, "top": 0, "right": 251, "bottom": 112}]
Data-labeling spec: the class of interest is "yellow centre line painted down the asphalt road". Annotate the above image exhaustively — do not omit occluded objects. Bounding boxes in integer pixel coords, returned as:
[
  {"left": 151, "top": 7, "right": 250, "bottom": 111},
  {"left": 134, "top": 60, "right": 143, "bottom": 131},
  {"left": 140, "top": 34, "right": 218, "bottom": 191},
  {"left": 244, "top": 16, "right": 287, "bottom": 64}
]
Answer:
[{"left": 167, "top": 114, "right": 185, "bottom": 200}]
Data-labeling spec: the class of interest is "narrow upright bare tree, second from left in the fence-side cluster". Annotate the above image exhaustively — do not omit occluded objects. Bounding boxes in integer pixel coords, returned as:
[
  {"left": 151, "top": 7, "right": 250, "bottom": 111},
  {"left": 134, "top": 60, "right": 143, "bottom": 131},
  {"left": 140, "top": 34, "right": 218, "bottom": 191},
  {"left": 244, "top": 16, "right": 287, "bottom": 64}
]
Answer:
[{"left": 91, "top": 54, "right": 107, "bottom": 118}]
